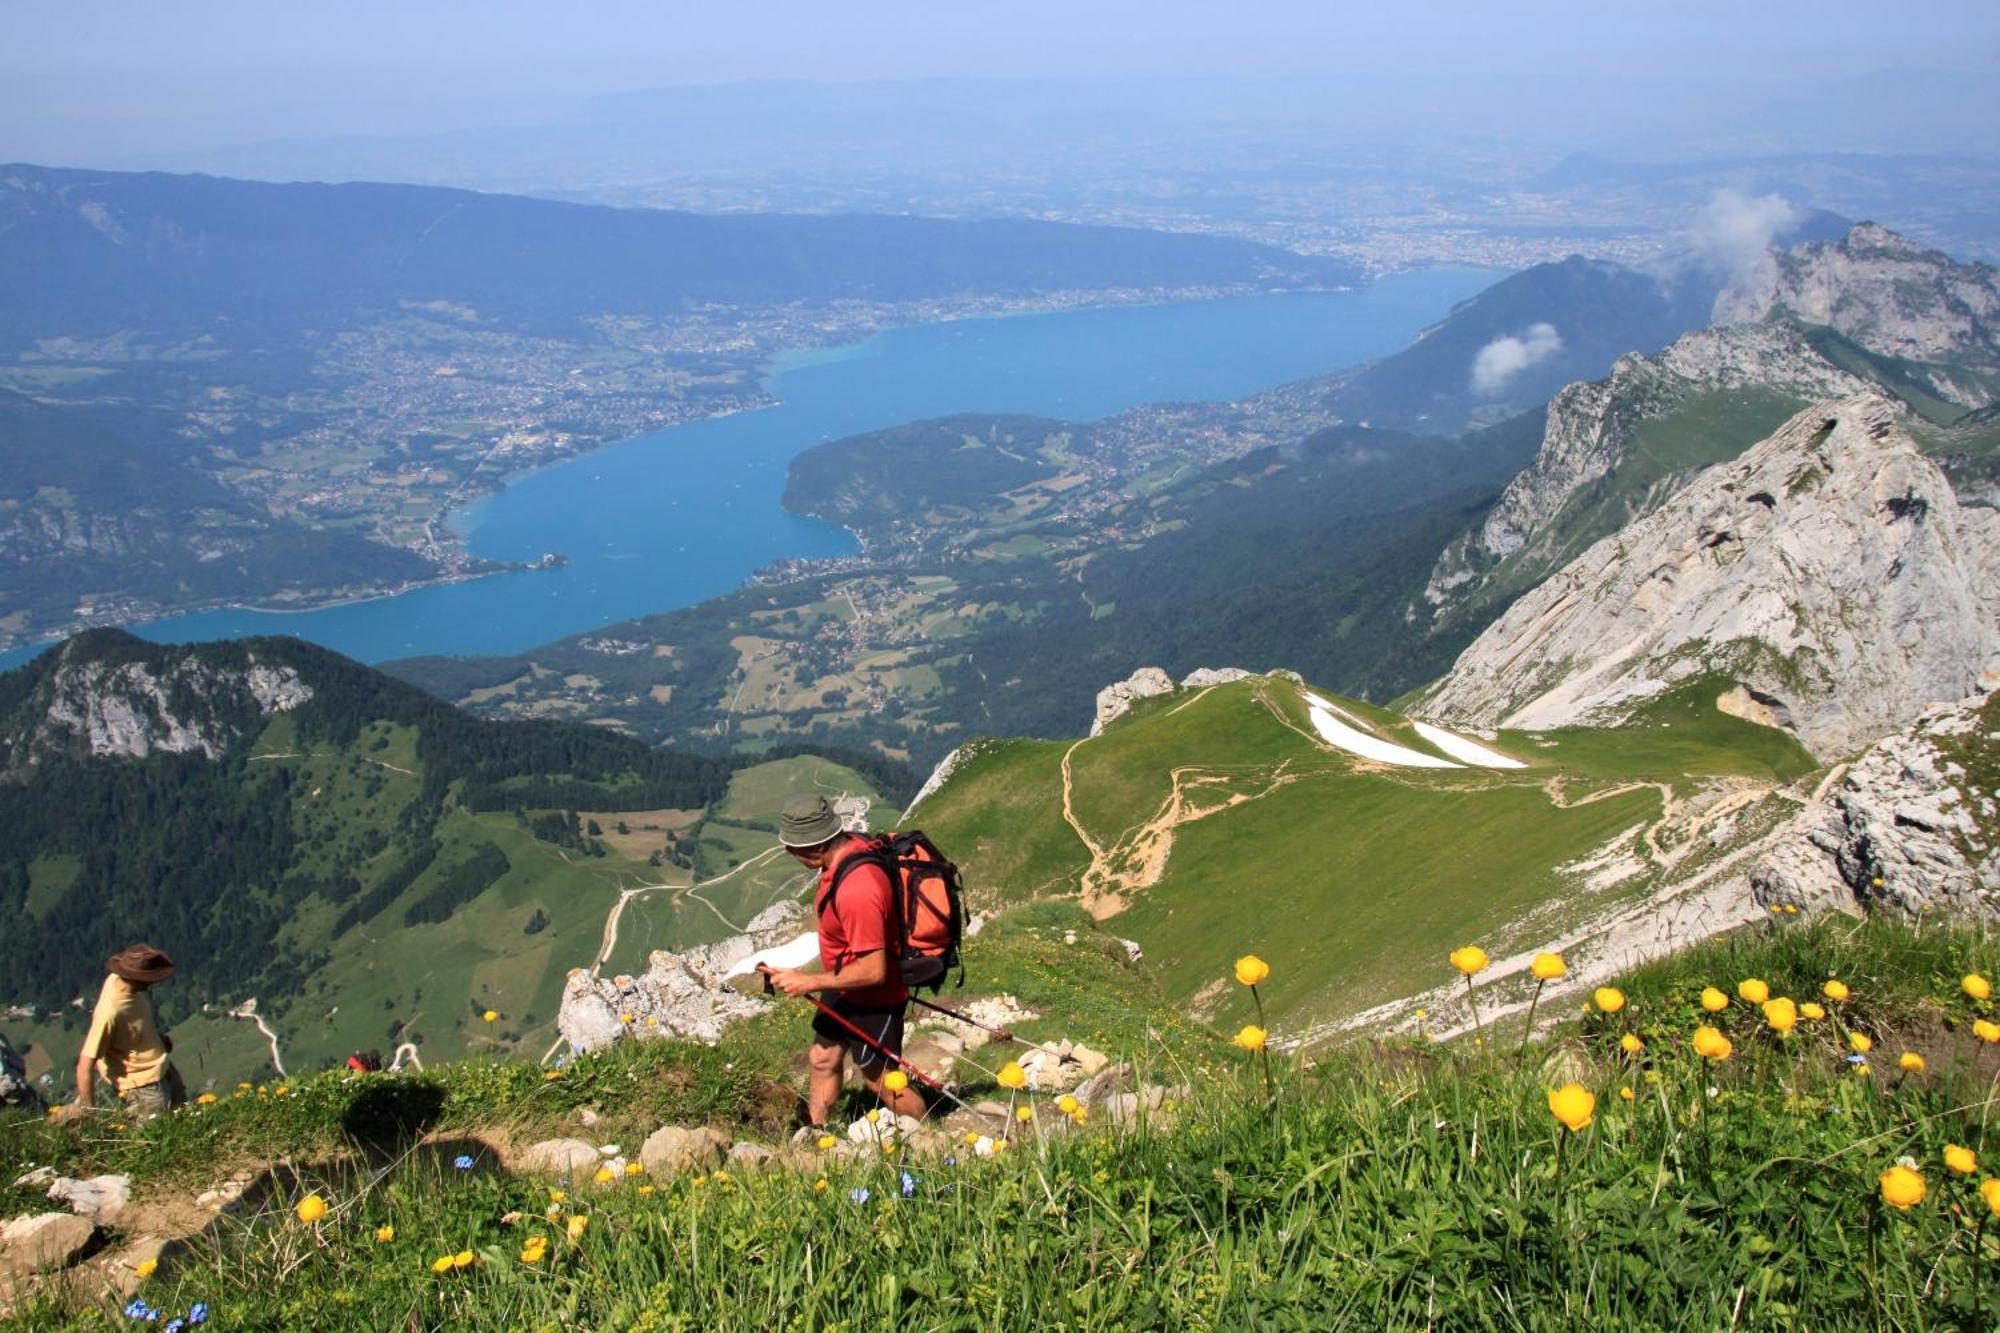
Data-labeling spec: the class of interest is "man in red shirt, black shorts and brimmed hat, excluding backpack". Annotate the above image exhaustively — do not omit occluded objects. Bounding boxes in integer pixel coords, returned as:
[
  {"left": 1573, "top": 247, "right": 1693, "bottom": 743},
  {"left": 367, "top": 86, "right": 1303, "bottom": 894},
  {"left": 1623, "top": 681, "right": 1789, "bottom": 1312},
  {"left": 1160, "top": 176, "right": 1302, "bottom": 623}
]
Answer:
[{"left": 770, "top": 797, "right": 924, "bottom": 1125}]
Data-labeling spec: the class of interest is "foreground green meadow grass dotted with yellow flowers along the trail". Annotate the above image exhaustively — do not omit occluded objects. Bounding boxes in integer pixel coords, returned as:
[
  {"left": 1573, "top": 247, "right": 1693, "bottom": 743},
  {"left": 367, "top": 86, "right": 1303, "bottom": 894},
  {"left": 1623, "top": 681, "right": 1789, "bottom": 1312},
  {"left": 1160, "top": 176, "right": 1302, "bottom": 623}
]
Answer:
[{"left": 11, "top": 909, "right": 2000, "bottom": 1329}]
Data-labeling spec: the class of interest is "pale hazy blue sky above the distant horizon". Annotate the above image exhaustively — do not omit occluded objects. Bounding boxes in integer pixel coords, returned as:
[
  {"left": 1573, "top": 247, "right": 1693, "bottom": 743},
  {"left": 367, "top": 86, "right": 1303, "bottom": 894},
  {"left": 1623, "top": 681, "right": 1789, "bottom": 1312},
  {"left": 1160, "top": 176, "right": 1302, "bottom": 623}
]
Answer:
[{"left": 11, "top": 0, "right": 2000, "bottom": 162}]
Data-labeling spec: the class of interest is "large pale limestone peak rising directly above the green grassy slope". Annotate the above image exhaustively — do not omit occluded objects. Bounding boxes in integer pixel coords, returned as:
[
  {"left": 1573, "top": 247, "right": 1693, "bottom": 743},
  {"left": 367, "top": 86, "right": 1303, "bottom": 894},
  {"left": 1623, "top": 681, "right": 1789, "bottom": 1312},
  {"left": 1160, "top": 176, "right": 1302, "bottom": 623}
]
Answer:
[{"left": 1424, "top": 394, "right": 2000, "bottom": 759}]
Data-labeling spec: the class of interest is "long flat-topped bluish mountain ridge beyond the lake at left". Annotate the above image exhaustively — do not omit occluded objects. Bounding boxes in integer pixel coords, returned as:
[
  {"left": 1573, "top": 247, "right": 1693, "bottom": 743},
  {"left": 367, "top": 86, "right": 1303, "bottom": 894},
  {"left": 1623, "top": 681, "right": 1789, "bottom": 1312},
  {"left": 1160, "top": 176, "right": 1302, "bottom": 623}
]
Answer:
[{"left": 0, "top": 164, "right": 1356, "bottom": 348}]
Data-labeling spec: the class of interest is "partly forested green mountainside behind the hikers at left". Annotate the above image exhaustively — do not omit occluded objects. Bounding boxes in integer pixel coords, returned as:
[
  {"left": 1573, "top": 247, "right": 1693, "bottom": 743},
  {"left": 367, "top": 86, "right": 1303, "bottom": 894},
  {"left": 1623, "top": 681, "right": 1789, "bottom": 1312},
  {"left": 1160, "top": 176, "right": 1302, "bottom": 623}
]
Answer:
[{"left": 0, "top": 630, "right": 892, "bottom": 1077}]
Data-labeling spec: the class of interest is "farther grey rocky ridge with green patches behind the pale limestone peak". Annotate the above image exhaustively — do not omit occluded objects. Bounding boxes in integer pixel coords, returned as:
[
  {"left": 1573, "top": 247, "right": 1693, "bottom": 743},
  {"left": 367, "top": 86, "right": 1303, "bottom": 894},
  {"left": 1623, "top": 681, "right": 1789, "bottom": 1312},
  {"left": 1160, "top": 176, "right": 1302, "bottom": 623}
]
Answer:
[{"left": 1412, "top": 224, "right": 2000, "bottom": 626}]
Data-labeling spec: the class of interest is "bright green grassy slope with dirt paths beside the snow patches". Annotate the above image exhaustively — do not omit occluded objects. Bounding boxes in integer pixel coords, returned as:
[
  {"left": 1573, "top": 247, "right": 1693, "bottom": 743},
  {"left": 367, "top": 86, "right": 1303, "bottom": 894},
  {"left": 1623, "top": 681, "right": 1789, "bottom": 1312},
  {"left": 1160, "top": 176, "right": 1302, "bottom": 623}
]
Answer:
[{"left": 910, "top": 677, "right": 1814, "bottom": 1029}]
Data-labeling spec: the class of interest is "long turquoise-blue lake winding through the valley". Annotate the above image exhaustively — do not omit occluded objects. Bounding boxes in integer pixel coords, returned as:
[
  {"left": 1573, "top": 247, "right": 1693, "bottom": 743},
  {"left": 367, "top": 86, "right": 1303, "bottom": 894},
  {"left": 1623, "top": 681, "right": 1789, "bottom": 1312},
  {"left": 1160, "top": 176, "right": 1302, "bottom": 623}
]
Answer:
[{"left": 0, "top": 268, "right": 1496, "bottom": 667}]
